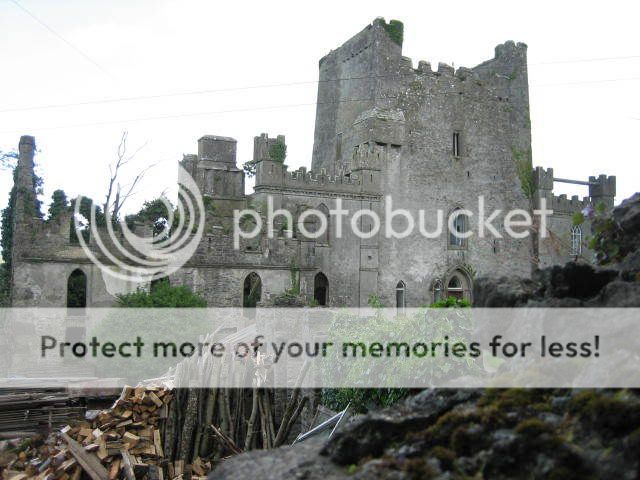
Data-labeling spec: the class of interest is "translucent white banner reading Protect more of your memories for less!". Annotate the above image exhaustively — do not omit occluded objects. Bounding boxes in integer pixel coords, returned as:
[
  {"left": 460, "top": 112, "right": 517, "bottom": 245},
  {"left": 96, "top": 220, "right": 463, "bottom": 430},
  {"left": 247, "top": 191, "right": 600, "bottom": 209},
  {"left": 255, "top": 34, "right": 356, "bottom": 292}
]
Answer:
[{"left": 0, "top": 308, "right": 640, "bottom": 388}]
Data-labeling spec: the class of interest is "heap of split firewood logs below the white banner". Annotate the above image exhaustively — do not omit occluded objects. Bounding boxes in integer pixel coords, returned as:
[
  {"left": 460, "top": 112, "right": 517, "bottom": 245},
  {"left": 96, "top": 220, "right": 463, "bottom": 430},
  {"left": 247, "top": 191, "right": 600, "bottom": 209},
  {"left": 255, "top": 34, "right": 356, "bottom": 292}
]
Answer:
[{"left": 3, "top": 387, "right": 211, "bottom": 480}]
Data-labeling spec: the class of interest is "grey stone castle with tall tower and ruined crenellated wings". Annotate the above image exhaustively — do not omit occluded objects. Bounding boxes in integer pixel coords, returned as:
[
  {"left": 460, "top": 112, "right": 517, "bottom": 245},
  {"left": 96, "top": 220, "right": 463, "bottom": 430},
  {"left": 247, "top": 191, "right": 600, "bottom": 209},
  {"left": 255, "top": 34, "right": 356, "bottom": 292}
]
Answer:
[{"left": 6, "top": 19, "right": 615, "bottom": 307}]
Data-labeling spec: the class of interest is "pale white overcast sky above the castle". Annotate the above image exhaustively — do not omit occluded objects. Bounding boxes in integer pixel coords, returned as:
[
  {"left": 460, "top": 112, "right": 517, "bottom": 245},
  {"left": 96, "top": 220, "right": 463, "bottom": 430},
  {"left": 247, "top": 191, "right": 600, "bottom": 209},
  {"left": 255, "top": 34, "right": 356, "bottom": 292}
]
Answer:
[{"left": 0, "top": 0, "right": 640, "bottom": 221}]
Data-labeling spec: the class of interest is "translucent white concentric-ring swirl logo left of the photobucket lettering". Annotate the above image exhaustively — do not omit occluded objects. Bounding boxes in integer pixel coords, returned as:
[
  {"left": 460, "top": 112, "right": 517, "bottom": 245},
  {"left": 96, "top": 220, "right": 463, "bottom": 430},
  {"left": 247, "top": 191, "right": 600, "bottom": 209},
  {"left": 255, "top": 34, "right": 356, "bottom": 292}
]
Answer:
[{"left": 74, "top": 166, "right": 205, "bottom": 283}]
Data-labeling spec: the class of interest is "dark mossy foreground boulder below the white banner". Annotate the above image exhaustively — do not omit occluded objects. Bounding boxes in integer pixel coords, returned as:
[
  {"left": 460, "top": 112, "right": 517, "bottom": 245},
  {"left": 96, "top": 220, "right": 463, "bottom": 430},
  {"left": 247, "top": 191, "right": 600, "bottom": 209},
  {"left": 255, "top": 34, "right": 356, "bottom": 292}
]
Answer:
[{"left": 210, "top": 389, "right": 640, "bottom": 480}]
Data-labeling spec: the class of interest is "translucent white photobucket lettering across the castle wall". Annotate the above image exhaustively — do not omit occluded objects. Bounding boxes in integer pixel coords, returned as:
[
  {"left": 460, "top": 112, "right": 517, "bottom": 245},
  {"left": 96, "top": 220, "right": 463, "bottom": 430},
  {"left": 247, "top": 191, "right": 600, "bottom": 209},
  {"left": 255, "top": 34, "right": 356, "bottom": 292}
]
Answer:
[{"left": 233, "top": 195, "right": 553, "bottom": 250}]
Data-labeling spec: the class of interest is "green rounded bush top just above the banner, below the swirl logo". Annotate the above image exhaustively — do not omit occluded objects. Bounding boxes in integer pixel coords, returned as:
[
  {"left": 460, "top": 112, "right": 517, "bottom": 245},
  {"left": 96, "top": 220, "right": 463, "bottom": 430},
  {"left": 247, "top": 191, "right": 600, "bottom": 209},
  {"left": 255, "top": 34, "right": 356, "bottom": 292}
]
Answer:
[{"left": 117, "top": 279, "right": 207, "bottom": 308}]
